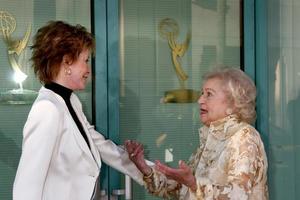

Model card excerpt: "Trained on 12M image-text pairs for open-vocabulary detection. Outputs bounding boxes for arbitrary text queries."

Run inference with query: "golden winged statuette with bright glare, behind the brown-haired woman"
[0,11,37,104]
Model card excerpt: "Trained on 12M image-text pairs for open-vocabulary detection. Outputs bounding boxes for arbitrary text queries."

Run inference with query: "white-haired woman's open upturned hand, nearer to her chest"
[155,160,197,191]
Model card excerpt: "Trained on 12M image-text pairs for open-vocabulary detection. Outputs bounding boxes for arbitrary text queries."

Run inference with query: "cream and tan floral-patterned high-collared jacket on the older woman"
[144,115,268,200]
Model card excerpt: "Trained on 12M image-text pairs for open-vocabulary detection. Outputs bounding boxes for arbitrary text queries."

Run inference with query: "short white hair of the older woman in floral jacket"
[204,67,256,123]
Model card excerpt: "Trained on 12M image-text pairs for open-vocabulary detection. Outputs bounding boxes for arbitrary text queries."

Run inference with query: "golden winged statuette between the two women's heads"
[159,18,199,103]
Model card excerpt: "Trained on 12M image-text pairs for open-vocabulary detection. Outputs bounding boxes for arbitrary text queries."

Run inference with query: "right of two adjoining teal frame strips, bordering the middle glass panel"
[107,0,123,193]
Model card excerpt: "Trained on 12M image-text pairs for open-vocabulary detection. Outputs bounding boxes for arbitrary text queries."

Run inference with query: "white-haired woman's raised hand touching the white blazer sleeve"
[124,140,152,175]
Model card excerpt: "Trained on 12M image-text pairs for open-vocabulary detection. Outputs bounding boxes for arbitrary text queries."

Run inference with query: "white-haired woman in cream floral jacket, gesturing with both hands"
[125,68,268,200]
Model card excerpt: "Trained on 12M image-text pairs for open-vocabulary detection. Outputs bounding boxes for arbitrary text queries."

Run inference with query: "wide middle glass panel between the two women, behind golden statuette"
[119,0,242,199]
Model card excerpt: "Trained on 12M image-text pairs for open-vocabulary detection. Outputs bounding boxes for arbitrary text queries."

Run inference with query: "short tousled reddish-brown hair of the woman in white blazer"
[31,21,95,83]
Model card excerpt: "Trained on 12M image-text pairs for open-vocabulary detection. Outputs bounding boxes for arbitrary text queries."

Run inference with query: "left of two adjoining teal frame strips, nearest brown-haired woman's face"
[92,0,109,193]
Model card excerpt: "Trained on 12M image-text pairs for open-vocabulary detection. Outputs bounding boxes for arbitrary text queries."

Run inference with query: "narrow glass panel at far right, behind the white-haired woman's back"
[268,0,300,200]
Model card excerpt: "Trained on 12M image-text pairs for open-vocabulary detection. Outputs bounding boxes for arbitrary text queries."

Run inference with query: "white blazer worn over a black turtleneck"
[13,87,143,200]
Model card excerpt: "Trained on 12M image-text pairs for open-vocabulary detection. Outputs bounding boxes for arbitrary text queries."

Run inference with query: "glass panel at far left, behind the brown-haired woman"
[0,0,92,199]
